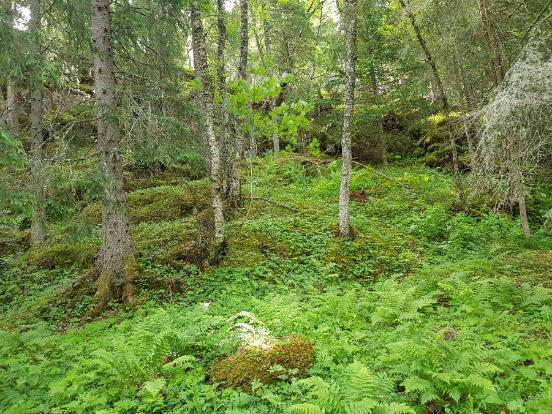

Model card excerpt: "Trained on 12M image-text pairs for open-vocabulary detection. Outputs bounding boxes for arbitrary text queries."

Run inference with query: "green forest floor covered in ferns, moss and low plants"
[0,155,552,414]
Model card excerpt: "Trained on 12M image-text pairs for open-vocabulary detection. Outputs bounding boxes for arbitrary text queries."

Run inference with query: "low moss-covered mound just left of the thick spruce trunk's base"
[27,240,100,269]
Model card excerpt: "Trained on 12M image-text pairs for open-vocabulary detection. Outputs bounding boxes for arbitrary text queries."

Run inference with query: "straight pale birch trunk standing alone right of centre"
[339,0,357,239]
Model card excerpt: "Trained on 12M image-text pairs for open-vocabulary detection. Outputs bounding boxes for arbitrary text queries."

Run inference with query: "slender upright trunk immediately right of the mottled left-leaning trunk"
[217,0,231,194]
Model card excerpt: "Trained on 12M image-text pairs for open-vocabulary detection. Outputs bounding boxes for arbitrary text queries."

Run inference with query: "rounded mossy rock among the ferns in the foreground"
[209,335,314,391]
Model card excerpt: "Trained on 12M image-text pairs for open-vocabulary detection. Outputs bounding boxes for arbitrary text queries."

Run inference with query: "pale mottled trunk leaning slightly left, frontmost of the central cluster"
[191,0,224,247]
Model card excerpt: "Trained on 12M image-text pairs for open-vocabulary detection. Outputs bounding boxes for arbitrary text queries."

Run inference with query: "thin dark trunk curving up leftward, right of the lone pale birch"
[399,0,465,205]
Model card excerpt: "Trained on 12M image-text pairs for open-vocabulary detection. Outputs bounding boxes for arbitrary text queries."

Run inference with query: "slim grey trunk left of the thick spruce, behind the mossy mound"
[29,0,46,246]
